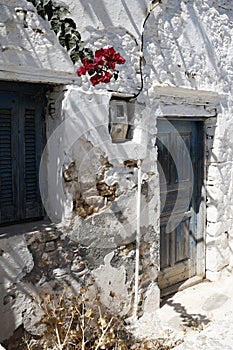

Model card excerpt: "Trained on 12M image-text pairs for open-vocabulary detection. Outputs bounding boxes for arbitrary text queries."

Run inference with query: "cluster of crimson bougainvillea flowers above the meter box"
[77,47,125,86]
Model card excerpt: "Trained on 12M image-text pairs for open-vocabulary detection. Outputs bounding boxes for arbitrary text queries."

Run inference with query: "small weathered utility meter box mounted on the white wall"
[109,100,129,142]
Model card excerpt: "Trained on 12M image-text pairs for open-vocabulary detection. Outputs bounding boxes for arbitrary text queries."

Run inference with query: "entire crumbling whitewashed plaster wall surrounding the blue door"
[0,0,233,339]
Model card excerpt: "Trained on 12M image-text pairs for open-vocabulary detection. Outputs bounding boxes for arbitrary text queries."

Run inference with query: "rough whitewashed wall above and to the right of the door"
[62,0,233,278]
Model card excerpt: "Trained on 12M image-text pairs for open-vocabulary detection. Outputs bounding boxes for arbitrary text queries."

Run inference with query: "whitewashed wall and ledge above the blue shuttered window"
[0,0,75,83]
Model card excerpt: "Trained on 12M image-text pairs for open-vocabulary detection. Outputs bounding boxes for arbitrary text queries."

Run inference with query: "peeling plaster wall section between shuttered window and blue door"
[41,87,159,309]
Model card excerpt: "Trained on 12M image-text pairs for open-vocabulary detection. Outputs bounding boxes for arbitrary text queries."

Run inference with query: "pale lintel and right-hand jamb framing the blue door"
[153,86,221,295]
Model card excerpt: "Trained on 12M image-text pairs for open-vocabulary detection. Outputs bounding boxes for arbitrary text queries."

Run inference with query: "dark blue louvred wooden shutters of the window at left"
[0,83,45,224]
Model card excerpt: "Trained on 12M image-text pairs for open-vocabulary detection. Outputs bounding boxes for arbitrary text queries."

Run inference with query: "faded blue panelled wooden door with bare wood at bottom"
[157,119,203,294]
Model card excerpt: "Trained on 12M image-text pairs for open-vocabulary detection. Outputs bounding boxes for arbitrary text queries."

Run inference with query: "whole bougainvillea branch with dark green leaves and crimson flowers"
[27,0,125,86]
